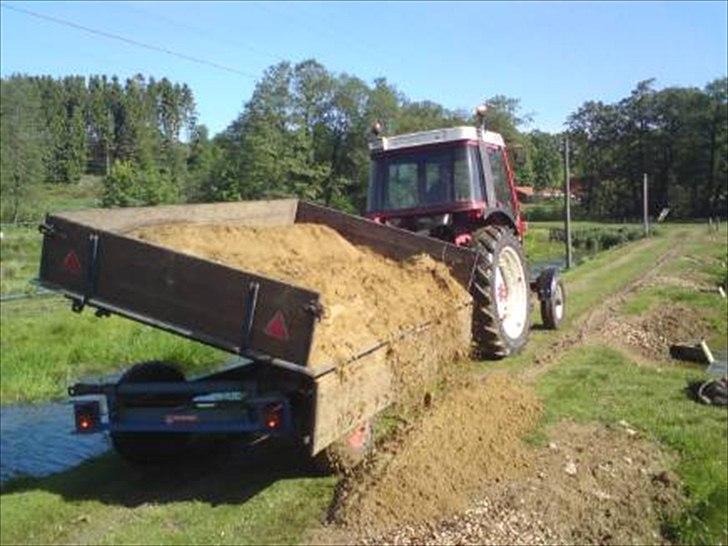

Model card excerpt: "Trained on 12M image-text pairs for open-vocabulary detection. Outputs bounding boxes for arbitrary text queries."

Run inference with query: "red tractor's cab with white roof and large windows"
[367,127,525,244]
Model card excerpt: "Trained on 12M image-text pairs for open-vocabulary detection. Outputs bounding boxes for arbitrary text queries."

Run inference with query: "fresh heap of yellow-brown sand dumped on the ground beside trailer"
[328,374,540,541]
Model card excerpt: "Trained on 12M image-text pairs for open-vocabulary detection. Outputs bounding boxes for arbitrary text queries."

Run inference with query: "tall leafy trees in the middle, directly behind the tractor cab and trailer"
[188,60,561,211]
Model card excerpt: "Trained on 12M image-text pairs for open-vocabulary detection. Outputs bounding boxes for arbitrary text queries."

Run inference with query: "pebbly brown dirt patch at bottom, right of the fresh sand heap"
[373,422,682,544]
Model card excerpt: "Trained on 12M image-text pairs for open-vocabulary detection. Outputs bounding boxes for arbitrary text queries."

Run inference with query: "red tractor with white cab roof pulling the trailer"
[367,108,565,358]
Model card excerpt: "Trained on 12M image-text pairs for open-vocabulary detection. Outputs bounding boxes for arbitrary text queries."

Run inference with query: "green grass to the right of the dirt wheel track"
[521,226,728,544]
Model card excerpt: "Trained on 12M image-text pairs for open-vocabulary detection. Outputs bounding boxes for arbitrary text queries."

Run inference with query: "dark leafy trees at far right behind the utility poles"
[568,78,728,218]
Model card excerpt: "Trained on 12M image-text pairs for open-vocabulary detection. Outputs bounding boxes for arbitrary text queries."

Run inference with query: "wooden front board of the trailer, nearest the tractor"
[296,201,476,288]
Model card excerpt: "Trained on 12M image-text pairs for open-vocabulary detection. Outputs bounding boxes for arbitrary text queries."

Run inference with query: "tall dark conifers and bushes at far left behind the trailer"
[0,75,196,221]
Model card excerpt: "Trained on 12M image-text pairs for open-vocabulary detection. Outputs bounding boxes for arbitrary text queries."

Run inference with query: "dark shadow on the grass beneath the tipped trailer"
[0,436,321,508]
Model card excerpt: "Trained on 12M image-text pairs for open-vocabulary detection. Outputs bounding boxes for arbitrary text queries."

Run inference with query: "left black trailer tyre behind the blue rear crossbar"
[110,362,190,465]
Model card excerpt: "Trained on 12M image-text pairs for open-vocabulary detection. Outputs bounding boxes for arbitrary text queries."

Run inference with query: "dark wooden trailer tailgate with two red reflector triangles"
[40,216,319,365]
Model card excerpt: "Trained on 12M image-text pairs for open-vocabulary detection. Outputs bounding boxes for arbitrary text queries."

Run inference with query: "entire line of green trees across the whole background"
[0,60,728,221]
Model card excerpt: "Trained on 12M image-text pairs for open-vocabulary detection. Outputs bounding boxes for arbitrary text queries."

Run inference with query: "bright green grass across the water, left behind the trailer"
[0,181,225,404]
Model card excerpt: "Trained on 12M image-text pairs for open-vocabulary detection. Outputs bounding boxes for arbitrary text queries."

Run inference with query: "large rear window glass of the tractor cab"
[367,143,483,212]
